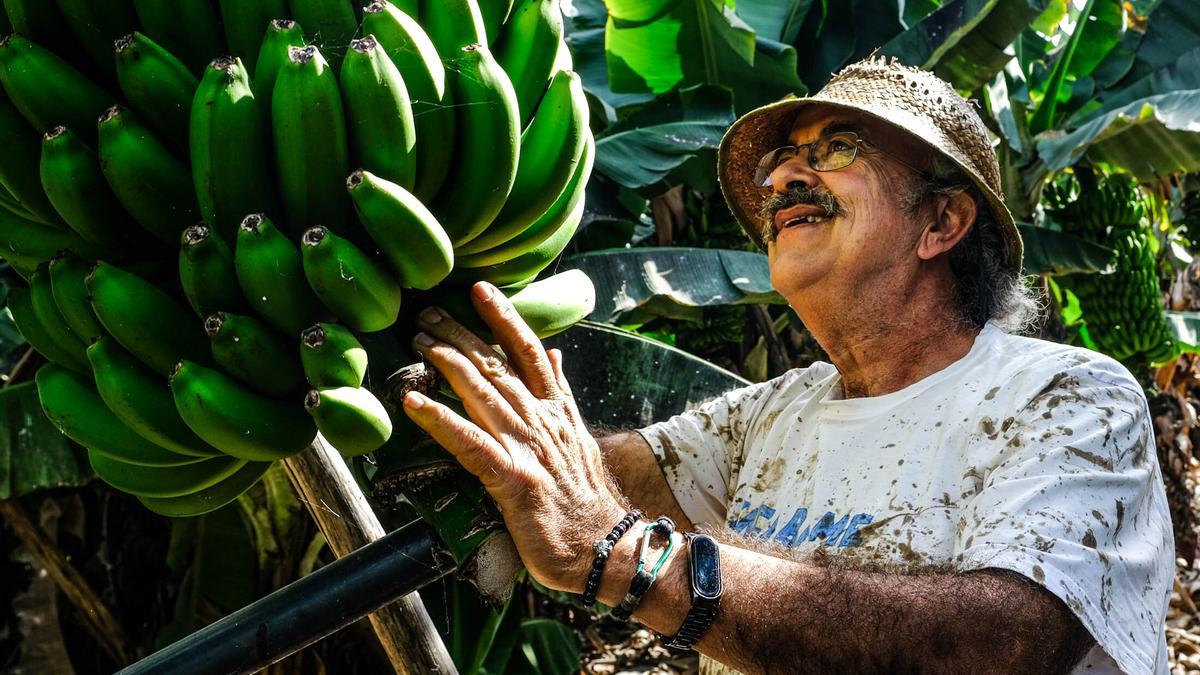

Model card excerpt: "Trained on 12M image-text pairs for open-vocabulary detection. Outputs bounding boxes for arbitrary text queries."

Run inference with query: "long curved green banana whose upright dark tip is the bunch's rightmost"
[431,44,521,246]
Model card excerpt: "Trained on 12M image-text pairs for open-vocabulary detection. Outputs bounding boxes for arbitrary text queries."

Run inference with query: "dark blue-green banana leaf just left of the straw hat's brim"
[595,85,734,189]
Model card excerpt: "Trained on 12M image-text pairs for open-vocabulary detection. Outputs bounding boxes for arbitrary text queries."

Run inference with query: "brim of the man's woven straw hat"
[716,96,1024,274]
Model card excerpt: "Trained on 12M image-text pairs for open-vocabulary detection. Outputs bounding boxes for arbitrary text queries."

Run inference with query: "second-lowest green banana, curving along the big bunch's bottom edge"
[88,450,246,497]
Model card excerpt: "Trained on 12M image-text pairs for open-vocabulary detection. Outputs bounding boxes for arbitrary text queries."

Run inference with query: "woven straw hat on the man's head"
[716,56,1022,274]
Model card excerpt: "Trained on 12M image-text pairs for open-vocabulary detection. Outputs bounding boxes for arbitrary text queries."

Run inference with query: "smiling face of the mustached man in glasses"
[764,108,929,297]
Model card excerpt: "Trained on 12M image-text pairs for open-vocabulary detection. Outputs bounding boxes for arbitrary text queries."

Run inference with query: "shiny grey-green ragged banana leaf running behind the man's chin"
[562,247,785,323]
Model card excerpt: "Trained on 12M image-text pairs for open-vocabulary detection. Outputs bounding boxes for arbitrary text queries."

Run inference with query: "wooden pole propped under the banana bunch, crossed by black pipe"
[283,436,457,675]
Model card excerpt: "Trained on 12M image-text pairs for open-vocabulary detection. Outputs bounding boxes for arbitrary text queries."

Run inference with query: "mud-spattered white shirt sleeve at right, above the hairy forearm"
[955,362,1175,674]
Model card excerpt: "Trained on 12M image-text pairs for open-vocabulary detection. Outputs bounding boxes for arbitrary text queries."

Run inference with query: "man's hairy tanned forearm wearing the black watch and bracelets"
[600,526,1091,674]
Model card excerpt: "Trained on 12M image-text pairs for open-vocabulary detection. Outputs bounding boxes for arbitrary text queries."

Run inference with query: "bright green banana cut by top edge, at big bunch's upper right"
[494,0,559,125]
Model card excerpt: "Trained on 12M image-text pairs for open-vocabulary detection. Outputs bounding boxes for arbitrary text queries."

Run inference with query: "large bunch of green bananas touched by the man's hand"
[0,0,594,515]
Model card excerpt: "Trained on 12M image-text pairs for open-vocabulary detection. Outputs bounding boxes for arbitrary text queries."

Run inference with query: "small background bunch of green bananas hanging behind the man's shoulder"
[1043,172,1180,363]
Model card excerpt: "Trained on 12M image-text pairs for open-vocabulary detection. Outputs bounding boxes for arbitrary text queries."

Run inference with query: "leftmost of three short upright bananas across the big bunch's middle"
[179,222,250,317]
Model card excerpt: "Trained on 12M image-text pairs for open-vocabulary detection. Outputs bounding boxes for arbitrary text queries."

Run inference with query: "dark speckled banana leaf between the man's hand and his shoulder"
[546,321,750,429]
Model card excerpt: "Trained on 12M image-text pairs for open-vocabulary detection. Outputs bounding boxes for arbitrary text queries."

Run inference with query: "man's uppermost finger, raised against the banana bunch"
[470,281,559,399]
